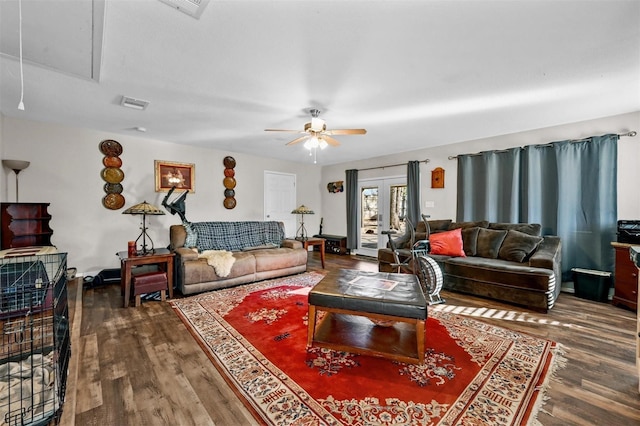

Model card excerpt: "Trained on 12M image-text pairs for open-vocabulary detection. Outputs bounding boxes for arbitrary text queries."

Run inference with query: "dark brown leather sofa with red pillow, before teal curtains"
[378,219,562,312]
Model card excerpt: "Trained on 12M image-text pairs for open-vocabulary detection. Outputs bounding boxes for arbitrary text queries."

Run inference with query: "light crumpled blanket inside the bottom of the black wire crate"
[0,352,58,425]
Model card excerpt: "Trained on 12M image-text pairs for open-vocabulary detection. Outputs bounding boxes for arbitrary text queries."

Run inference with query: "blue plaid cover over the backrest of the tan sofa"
[192,221,284,251]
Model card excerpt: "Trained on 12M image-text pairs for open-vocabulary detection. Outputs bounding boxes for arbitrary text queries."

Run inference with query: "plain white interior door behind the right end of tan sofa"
[264,171,296,238]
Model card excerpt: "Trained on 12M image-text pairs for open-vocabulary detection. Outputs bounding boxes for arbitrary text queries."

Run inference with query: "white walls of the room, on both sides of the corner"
[0,112,640,273]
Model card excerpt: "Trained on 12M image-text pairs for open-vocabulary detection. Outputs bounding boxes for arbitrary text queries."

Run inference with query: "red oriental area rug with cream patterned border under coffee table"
[171,273,560,426]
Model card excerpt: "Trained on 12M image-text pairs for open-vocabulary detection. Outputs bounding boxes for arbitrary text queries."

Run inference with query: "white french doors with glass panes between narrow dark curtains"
[356,177,407,257]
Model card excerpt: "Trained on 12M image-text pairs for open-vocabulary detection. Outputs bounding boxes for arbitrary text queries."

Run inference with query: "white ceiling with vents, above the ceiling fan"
[0,0,640,164]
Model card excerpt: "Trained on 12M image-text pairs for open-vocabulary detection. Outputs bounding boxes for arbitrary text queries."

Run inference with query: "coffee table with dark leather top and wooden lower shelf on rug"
[307,269,427,364]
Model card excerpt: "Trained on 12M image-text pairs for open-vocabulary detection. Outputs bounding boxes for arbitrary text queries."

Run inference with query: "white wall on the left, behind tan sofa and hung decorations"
[0,117,321,274]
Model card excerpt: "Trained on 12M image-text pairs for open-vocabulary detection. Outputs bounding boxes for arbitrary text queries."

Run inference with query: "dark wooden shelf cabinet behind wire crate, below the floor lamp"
[0,203,53,250]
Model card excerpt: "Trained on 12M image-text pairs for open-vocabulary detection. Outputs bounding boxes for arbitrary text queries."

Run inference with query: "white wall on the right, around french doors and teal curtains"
[322,112,640,235]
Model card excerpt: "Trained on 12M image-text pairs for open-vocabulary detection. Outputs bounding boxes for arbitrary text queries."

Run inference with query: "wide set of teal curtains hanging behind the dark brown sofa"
[456,134,619,280]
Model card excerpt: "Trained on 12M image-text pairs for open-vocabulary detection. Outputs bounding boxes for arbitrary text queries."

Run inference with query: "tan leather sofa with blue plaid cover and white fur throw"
[169,221,307,294]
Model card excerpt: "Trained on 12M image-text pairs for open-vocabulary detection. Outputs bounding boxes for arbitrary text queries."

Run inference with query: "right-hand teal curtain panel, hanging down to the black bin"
[522,135,619,280]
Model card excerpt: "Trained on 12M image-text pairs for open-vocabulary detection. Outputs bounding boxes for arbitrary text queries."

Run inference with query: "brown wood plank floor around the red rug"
[62,253,640,426]
